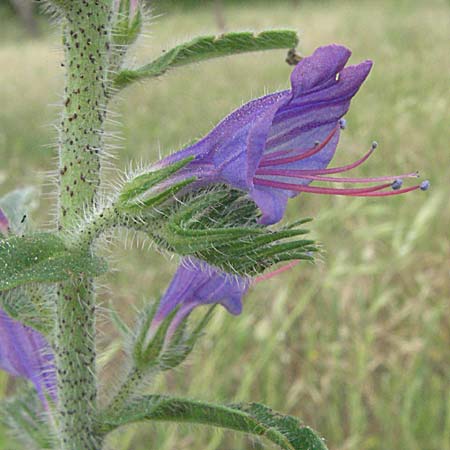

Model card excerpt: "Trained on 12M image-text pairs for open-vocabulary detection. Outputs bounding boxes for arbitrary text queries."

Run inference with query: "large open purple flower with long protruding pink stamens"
[157,45,428,224]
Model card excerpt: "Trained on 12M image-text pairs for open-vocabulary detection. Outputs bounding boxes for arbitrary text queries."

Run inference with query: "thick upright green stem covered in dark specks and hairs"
[55,0,111,450]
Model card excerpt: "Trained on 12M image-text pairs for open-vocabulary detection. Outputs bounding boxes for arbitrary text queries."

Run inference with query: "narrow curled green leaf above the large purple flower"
[115,30,298,88]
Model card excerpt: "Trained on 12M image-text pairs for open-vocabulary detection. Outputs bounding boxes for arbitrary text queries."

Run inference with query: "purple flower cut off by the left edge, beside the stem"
[0,309,56,407]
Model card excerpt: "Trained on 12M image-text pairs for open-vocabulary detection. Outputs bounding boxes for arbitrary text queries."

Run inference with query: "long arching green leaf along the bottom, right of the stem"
[99,395,326,450]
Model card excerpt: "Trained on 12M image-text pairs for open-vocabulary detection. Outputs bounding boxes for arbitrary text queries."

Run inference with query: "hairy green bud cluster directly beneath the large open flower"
[143,186,317,276]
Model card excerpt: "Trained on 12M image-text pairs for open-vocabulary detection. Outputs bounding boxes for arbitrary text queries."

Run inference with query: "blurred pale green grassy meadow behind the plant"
[0,0,450,450]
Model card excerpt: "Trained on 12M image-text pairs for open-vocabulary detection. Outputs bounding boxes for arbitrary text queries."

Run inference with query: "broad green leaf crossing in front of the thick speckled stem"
[0,233,107,291]
